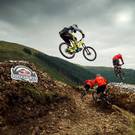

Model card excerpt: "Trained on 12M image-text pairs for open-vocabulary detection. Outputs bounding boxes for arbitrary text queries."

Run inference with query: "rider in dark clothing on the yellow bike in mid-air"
[59,24,85,52]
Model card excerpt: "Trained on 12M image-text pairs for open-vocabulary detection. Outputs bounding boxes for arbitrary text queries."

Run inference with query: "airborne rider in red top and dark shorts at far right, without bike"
[113,54,124,66]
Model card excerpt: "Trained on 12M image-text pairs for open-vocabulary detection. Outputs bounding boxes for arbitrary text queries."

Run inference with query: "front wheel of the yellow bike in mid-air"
[83,46,97,61]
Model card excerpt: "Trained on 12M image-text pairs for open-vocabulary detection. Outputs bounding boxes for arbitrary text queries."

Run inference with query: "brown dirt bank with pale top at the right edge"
[110,83,135,113]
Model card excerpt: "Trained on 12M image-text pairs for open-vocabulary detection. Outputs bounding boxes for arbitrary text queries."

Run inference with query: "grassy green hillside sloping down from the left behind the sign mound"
[0,41,94,84]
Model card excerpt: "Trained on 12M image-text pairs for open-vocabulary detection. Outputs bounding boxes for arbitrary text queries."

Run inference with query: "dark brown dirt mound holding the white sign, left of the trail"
[0,62,77,135]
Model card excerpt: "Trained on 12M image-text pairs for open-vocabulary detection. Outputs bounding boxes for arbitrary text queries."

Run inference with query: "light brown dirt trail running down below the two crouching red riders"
[55,87,129,135]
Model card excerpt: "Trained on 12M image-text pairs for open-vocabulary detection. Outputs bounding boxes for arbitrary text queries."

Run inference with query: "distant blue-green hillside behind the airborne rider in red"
[85,66,135,84]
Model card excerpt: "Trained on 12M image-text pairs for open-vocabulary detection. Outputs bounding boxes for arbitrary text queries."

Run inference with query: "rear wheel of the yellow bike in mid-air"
[59,43,75,59]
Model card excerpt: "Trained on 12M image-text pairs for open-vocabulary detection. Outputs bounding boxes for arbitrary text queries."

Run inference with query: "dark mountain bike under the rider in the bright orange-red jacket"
[92,88,112,108]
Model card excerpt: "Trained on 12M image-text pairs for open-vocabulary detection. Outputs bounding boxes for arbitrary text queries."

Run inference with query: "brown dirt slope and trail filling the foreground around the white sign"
[0,62,132,135]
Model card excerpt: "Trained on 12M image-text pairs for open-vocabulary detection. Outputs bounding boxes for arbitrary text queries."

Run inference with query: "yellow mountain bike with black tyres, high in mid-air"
[59,38,97,61]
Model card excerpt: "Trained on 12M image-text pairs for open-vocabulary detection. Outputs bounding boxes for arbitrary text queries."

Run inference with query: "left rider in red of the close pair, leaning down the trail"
[81,80,94,98]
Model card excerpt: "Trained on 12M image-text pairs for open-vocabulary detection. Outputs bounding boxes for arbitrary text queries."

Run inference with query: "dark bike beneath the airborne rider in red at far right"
[114,65,124,81]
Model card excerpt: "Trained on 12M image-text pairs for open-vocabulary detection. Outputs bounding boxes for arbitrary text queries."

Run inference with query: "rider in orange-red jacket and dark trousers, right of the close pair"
[94,74,107,94]
